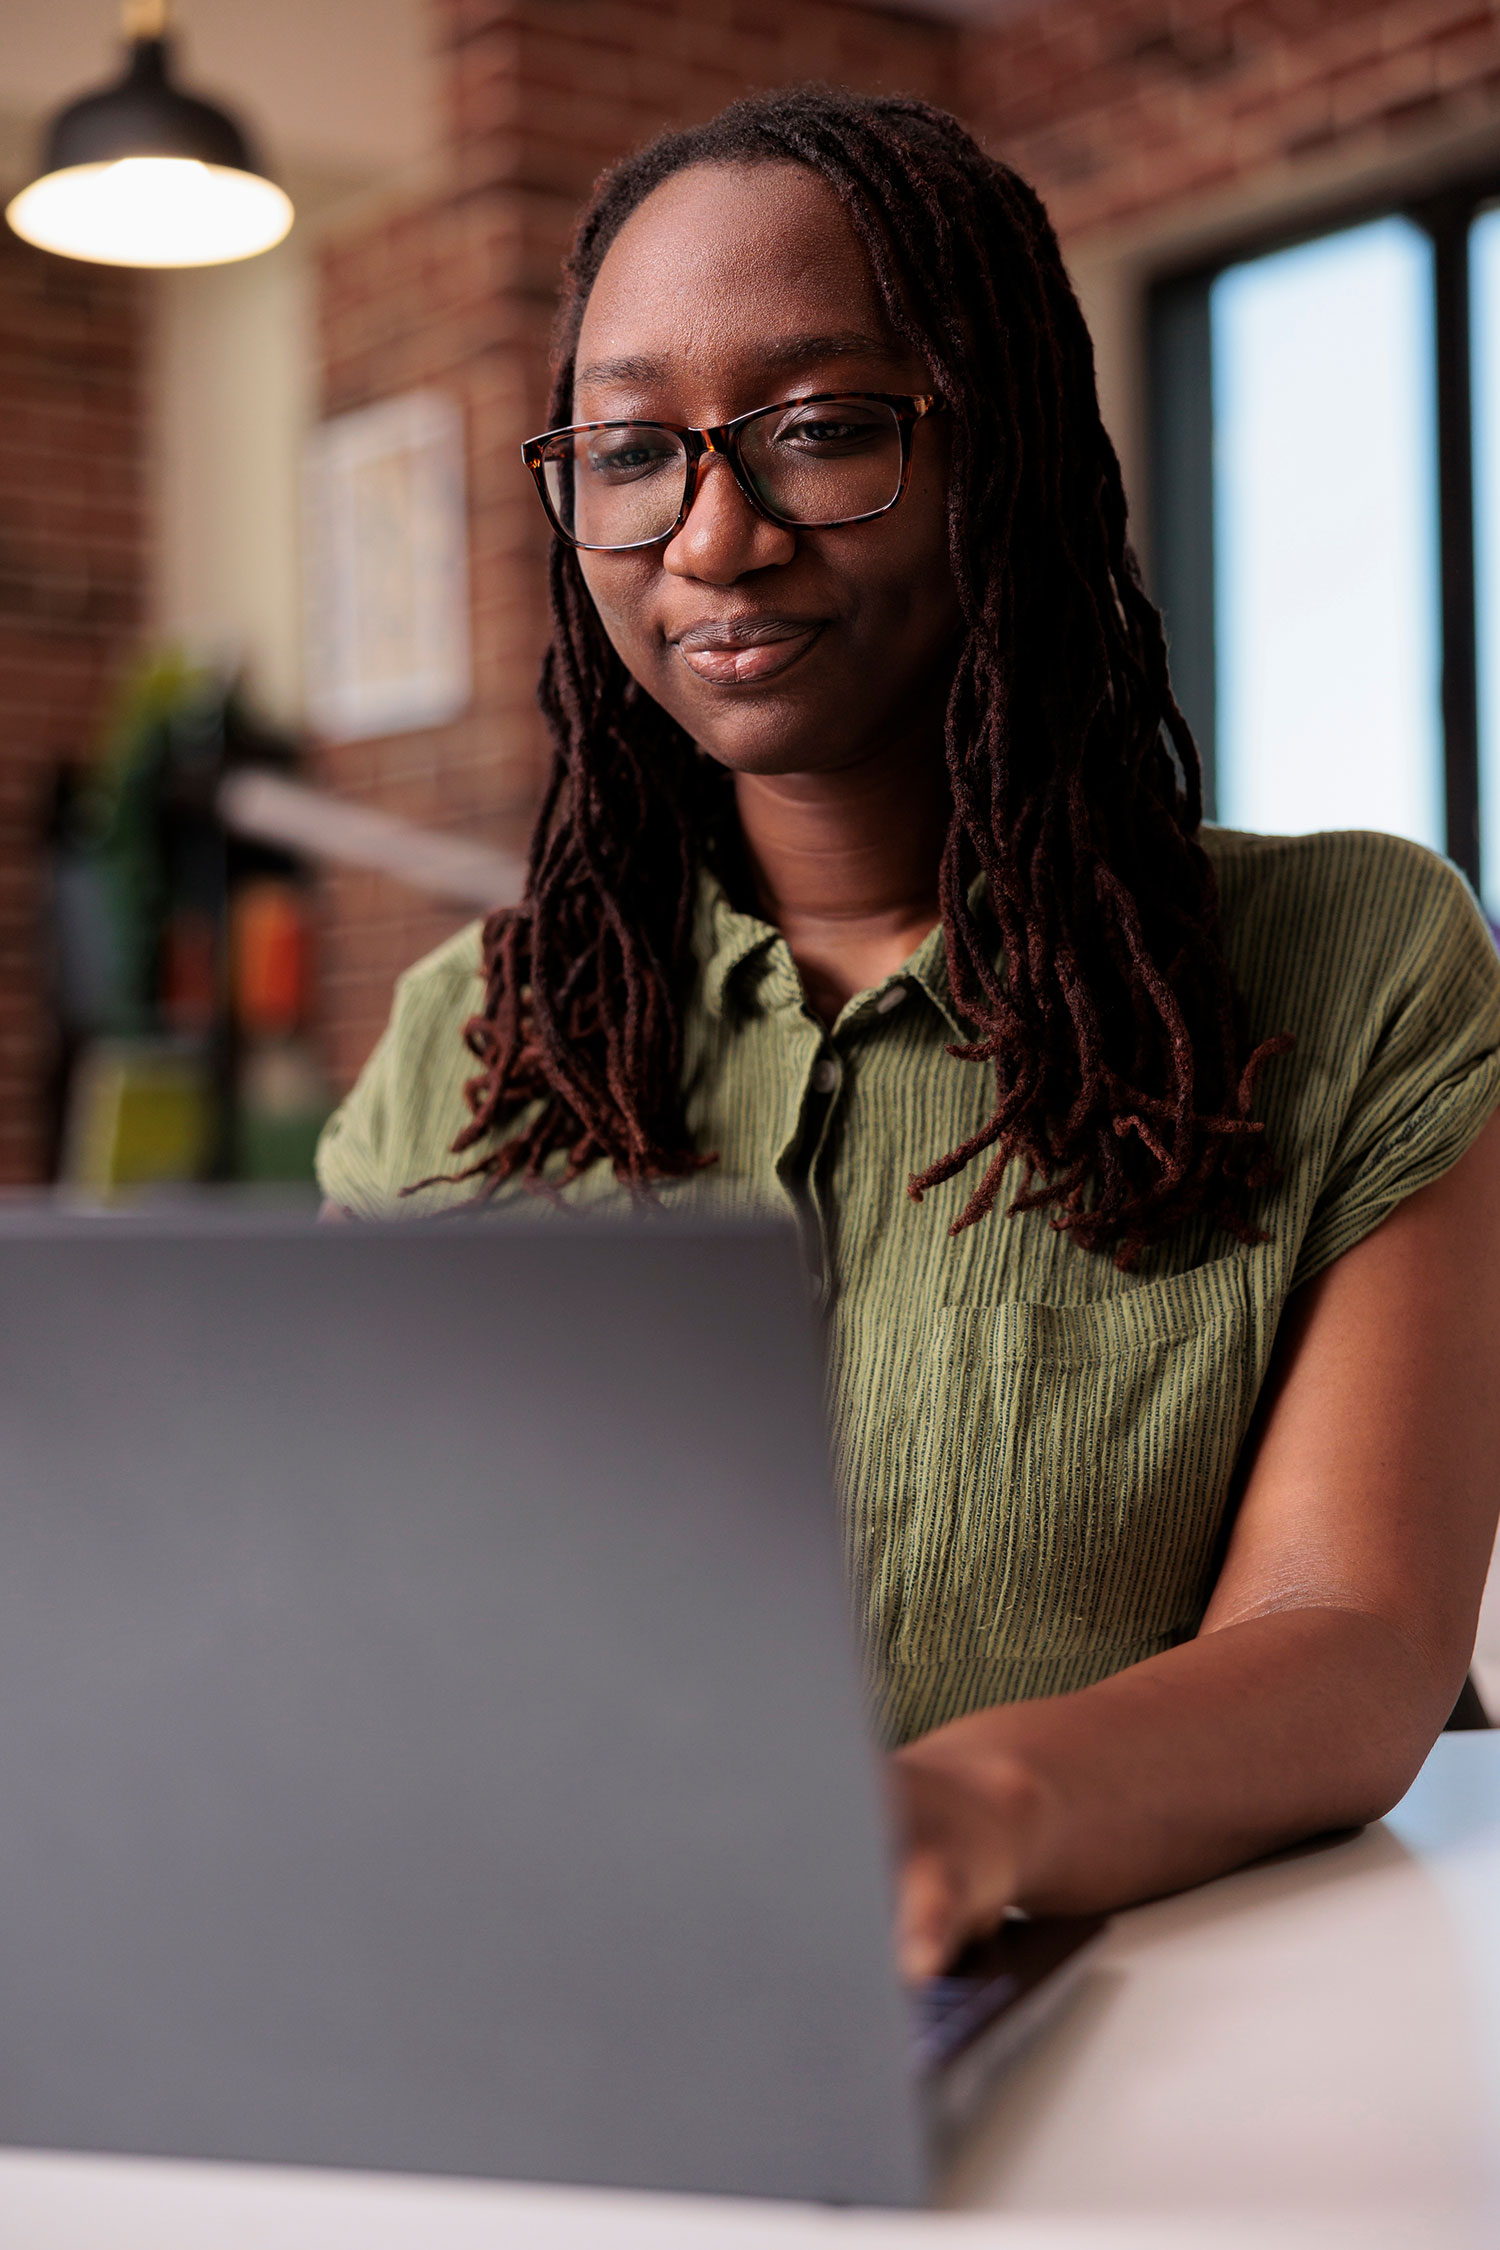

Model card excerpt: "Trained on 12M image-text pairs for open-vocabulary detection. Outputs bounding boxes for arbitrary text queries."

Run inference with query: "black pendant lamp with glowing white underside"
[4,0,292,266]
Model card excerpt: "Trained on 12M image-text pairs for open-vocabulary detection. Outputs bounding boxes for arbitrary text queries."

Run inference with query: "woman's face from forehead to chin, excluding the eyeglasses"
[573,164,960,774]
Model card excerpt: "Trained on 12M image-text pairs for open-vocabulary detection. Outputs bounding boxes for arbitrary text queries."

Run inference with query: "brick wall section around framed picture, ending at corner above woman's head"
[319,0,958,1085]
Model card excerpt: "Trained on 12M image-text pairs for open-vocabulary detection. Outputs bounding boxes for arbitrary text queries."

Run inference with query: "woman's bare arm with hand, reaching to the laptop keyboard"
[893,1116,1500,1976]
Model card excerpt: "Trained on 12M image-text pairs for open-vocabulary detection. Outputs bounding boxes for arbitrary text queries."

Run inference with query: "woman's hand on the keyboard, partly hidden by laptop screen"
[891,1730,1043,1985]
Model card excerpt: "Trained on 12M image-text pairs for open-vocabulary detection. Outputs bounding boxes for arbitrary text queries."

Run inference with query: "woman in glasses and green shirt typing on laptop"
[322,90,1500,1976]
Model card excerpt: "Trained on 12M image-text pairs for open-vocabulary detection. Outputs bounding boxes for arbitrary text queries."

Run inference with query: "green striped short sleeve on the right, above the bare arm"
[1293,837,1500,1287]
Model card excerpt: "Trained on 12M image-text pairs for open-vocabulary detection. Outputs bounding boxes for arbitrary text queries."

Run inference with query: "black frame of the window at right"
[1145,167,1500,889]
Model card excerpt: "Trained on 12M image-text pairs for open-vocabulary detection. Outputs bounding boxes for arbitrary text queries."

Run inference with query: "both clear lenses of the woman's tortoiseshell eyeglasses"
[542,398,902,547]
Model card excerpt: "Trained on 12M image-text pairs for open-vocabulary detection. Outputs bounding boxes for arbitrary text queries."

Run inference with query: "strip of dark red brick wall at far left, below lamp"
[0,225,146,1186]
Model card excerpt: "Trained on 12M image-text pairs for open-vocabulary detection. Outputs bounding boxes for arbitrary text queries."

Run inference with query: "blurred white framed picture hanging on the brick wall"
[304,392,472,743]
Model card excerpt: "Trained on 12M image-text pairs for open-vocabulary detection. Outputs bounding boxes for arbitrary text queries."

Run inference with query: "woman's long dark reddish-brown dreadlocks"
[454,86,1289,1265]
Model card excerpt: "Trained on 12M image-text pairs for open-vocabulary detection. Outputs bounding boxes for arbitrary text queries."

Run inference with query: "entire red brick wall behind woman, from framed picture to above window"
[322,0,1500,1082]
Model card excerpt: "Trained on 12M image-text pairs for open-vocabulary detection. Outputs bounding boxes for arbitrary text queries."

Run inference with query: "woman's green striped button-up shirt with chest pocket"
[319,830,1500,1742]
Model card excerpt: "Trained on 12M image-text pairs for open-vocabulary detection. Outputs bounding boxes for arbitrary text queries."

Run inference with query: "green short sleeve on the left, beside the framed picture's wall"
[315,923,484,1217]
